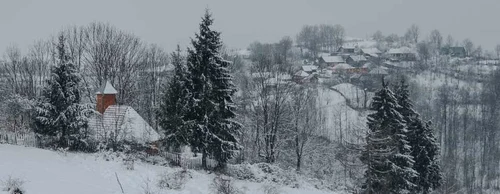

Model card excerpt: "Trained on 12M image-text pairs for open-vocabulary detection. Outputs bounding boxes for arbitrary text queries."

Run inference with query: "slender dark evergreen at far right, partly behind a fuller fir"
[396,78,442,193]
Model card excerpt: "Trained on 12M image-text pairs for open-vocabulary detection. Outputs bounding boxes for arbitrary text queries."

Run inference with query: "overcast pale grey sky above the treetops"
[0,0,500,54]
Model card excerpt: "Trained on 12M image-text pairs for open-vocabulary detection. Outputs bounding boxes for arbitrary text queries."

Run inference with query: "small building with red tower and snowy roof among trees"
[89,81,160,143]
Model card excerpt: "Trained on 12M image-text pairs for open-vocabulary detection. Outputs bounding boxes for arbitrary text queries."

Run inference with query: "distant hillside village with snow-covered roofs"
[237,39,474,91]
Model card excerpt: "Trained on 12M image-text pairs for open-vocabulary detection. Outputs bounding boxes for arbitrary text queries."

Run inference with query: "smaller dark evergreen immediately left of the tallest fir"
[157,45,192,149]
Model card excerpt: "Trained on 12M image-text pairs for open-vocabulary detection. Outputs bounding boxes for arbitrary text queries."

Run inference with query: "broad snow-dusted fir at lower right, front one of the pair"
[361,79,418,194]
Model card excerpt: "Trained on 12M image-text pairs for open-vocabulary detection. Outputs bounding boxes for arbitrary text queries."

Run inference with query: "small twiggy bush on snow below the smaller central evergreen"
[158,168,192,190]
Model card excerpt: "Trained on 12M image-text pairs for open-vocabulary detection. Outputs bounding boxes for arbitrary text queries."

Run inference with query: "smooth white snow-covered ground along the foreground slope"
[0,144,340,194]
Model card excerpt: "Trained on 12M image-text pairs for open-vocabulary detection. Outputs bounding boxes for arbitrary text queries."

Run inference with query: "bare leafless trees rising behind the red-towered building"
[0,22,170,135]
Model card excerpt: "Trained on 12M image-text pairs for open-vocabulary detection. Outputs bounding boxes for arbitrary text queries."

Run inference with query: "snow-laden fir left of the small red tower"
[35,35,89,150]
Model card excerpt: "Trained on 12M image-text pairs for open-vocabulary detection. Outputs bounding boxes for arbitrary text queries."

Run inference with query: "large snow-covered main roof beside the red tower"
[89,105,160,143]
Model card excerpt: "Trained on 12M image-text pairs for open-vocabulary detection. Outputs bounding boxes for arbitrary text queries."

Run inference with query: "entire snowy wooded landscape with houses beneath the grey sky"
[0,4,500,194]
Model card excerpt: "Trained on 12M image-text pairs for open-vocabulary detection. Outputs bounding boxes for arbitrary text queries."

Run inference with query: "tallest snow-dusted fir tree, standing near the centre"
[186,10,241,168]
